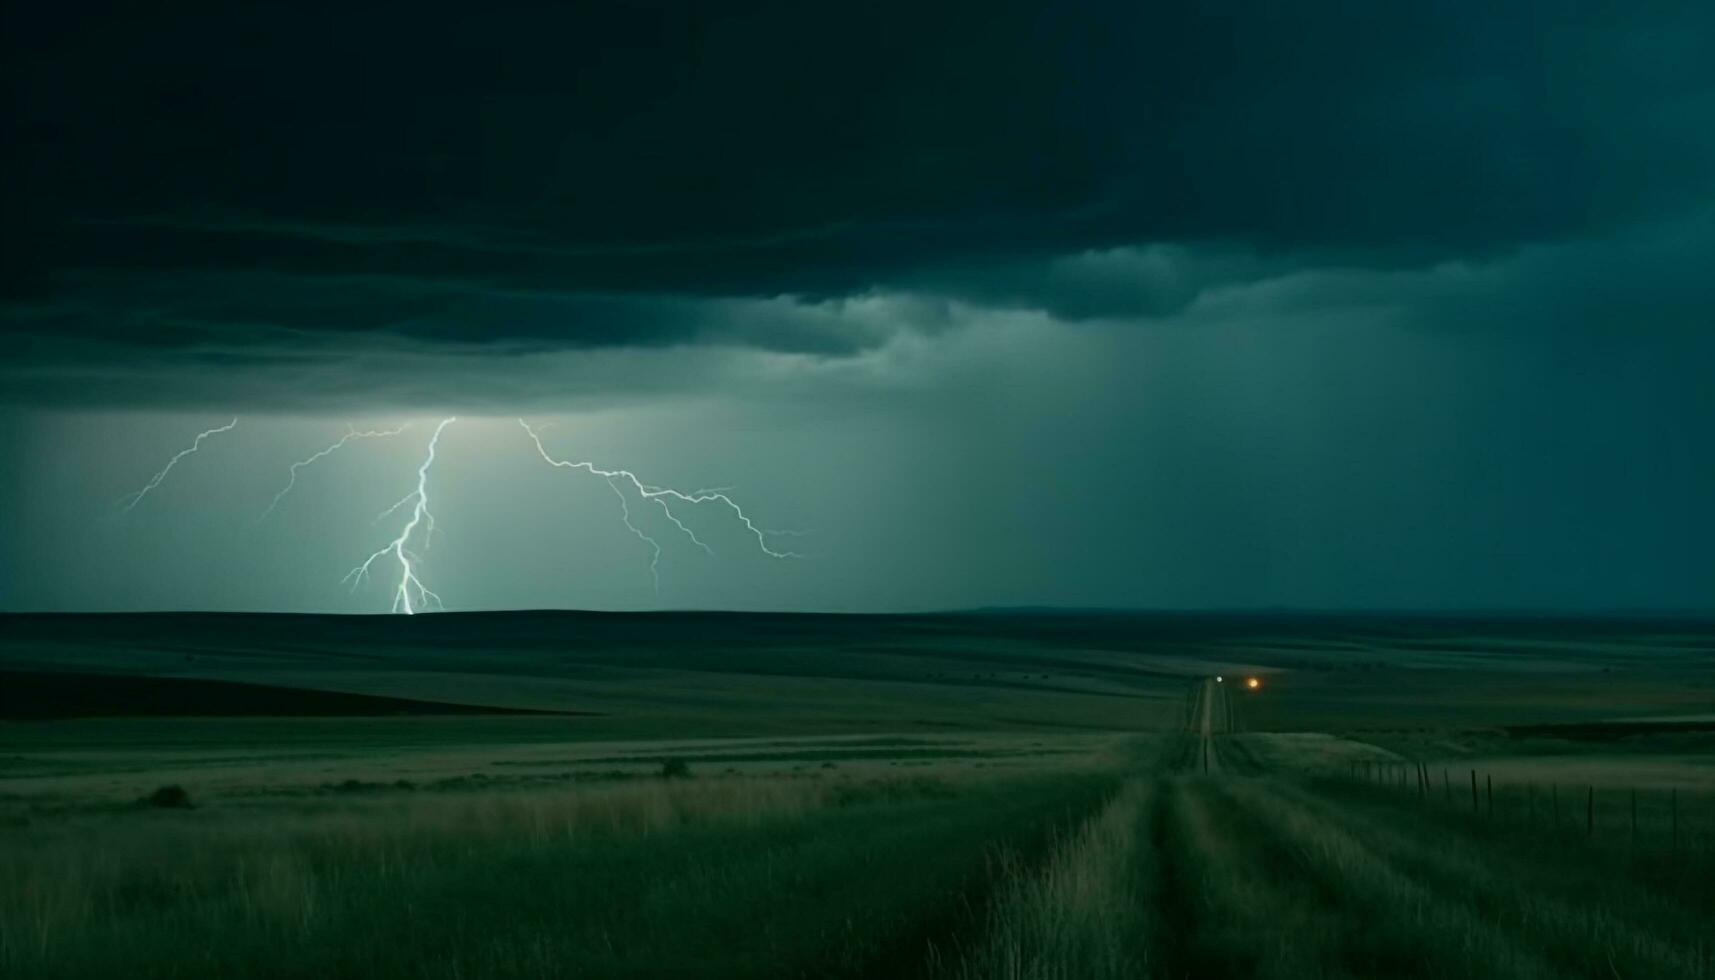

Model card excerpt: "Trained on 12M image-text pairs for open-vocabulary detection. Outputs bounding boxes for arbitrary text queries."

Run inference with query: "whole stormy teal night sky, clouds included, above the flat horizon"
[0,0,1715,613]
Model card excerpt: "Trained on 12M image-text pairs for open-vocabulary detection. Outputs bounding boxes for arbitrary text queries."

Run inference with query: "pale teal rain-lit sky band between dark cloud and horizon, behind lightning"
[0,307,1715,613]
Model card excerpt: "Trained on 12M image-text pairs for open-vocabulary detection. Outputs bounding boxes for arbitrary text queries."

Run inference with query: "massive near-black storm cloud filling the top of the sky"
[0,0,1715,398]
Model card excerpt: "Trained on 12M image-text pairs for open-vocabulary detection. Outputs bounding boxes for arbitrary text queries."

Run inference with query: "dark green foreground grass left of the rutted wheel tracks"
[0,776,1113,978]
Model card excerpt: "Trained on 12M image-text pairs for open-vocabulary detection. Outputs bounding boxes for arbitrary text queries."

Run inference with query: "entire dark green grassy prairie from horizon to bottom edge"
[0,614,1715,978]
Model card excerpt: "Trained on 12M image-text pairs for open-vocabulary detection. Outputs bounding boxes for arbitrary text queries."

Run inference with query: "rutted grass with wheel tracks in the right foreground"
[957,776,1715,980]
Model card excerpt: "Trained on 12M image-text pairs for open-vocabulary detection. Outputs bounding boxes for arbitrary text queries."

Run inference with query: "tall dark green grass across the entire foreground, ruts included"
[10,743,1715,980]
